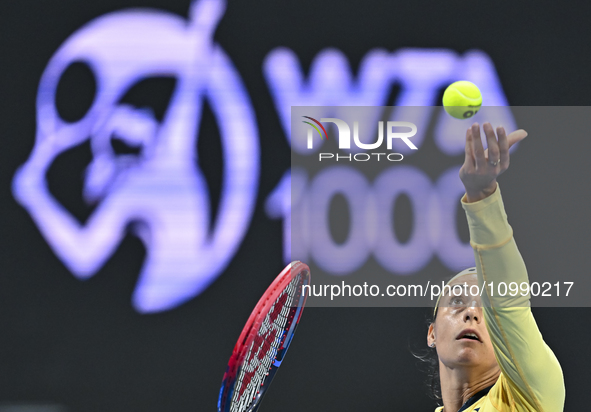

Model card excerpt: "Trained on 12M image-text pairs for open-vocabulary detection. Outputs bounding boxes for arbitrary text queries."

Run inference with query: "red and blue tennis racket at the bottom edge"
[218,261,310,412]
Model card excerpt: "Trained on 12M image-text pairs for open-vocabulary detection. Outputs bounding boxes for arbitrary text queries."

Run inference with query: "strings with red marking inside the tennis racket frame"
[230,275,302,412]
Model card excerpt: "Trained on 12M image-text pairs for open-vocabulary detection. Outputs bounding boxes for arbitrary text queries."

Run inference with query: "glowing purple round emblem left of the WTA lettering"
[13,0,259,312]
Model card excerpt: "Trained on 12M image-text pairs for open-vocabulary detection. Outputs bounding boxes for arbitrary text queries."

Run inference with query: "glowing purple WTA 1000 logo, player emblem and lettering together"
[13,0,515,312]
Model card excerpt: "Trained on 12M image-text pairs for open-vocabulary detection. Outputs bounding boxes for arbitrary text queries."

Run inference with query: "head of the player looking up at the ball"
[427,268,499,388]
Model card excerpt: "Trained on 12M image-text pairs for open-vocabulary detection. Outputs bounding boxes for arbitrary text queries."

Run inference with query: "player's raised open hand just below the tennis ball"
[460,122,527,203]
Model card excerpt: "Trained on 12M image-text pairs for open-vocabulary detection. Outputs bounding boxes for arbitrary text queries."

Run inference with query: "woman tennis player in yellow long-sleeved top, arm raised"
[427,123,565,412]
